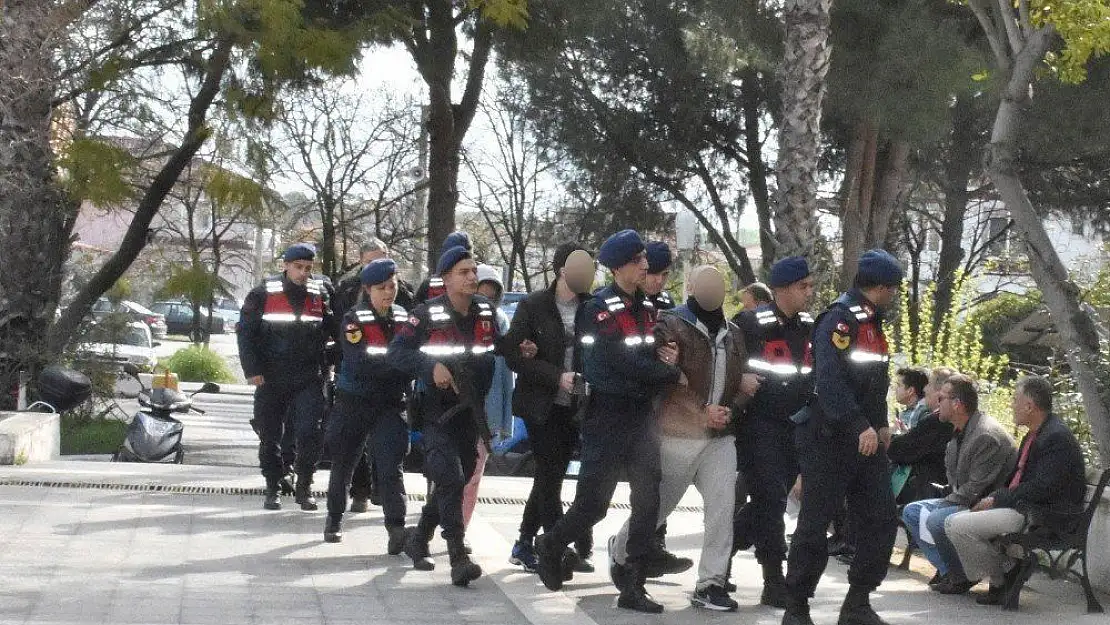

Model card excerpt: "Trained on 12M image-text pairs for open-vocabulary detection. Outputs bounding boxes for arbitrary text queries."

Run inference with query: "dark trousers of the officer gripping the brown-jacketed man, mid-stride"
[549,394,663,564]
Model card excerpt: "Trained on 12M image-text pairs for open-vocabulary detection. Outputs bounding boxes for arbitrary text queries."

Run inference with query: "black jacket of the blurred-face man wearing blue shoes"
[500,283,589,423]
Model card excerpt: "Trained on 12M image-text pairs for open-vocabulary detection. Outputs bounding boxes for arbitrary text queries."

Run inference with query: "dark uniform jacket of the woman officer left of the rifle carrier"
[335,304,412,412]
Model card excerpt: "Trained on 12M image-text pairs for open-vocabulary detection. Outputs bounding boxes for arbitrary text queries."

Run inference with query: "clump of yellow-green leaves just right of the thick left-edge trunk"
[58,139,138,206]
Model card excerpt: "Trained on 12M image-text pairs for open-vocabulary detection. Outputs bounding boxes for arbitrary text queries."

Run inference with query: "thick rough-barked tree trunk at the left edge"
[0,0,79,395]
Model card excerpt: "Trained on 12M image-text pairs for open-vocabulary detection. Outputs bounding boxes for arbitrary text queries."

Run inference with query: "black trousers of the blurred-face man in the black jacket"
[521,405,578,538]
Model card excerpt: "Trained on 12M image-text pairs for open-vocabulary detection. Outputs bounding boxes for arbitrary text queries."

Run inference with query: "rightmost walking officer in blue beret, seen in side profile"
[783,250,902,625]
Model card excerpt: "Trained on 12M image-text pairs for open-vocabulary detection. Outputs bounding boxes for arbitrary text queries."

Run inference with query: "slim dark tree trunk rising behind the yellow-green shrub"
[930,94,980,335]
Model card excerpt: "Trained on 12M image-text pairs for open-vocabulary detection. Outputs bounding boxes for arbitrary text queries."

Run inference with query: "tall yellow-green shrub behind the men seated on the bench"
[895,275,1009,384]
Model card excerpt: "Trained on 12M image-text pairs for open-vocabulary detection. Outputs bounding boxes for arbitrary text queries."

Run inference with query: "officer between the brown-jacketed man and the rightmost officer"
[734,256,814,607]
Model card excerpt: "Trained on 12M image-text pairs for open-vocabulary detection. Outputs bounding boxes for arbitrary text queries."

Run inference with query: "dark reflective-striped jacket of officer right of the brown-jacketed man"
[735,304,814,421]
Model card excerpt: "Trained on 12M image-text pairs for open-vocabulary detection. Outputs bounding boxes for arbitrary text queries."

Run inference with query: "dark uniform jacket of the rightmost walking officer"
[810,289,890,435]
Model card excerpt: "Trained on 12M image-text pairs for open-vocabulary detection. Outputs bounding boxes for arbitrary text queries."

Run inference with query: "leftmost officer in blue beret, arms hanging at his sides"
[236,243,334,511]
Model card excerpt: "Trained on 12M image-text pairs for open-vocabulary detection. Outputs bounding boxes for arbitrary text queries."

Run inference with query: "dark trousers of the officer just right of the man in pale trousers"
[733,413,798,564]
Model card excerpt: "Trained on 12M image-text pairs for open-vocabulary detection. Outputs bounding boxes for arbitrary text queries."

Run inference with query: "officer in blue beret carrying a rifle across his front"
[387,245,500,586]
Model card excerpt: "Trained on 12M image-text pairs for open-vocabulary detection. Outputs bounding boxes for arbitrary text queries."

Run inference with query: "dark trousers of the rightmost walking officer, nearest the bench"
[786,421,898,599]
